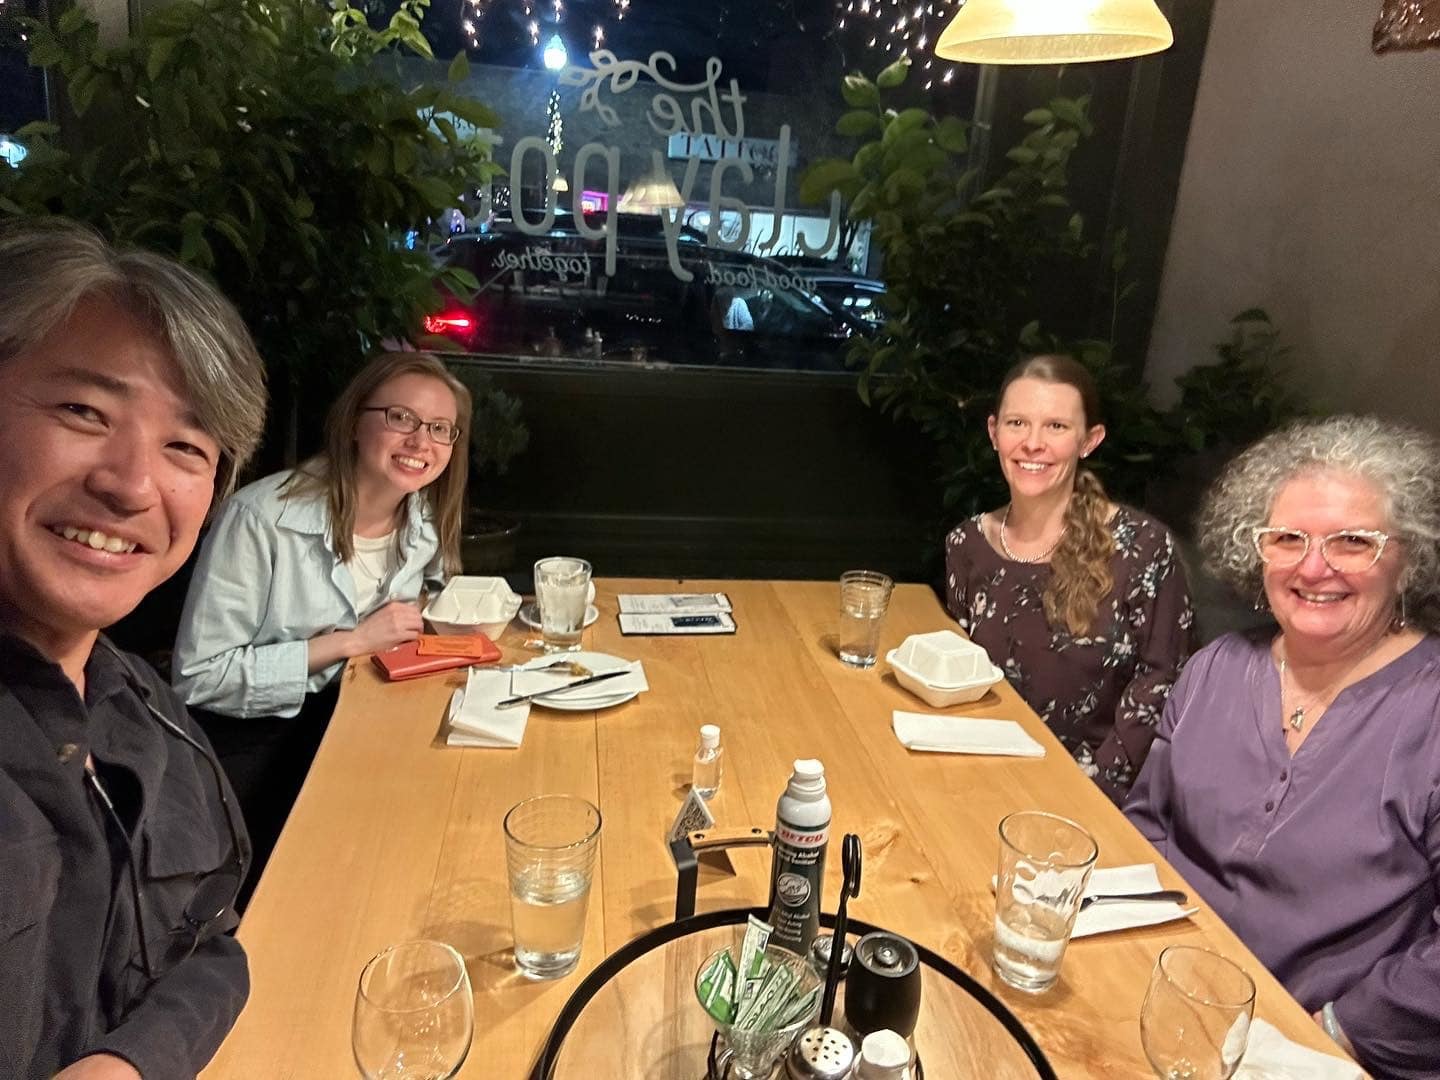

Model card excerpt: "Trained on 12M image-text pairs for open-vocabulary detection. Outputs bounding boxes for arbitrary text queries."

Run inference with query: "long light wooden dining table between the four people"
[206,580,1338,1080]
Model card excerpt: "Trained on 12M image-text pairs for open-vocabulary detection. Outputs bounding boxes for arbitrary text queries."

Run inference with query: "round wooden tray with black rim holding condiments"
[530,909,1057,1080]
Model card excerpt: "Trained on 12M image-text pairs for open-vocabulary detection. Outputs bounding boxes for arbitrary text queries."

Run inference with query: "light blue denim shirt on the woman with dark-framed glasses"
[171,472,442,717]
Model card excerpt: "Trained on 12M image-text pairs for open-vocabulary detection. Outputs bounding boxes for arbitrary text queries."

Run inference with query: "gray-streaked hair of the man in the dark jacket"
[0,217,265,498]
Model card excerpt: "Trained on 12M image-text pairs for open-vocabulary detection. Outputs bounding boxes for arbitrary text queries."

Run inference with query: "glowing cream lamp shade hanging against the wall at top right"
[935,0,1175,63]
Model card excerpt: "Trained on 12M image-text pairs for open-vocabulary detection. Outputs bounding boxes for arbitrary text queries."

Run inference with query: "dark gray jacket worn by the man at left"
[0,635,249,1080]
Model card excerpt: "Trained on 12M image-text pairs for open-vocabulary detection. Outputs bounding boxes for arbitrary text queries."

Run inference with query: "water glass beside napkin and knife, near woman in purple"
[994,811,1100,994]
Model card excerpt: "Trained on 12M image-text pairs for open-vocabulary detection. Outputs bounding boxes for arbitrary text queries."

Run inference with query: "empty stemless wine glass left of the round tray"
[350,942,475,1080]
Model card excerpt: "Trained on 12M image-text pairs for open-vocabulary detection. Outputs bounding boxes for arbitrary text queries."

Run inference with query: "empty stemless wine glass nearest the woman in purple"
[1140,945,1256,1080]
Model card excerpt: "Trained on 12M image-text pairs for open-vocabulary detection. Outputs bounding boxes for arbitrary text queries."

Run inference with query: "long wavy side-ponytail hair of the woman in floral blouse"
[995,356,1115,638]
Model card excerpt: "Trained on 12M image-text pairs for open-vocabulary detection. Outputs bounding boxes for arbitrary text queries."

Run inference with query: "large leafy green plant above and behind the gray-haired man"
[0,0,498,459]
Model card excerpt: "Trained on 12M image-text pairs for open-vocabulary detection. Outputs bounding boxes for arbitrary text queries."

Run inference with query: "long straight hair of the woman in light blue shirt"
[282,353,472,573]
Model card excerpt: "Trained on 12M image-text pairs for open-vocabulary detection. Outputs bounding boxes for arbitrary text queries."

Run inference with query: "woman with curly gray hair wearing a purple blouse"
[1126,416,1440,1077]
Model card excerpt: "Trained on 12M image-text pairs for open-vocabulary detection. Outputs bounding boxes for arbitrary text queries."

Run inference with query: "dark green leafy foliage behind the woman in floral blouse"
[801,60,1300,517]
